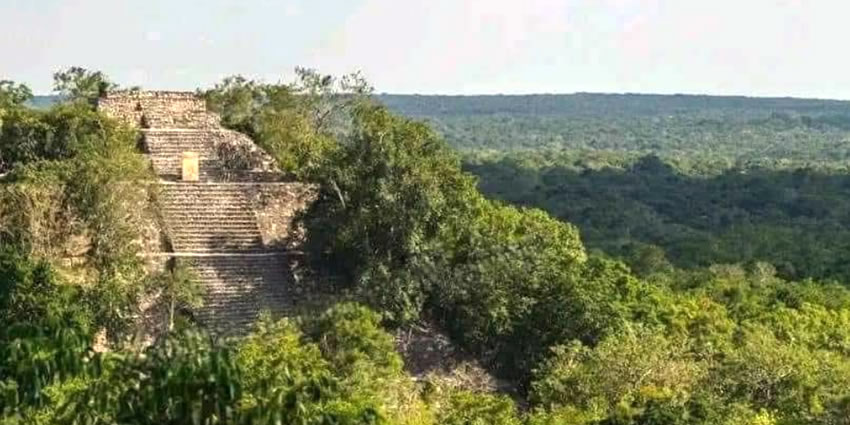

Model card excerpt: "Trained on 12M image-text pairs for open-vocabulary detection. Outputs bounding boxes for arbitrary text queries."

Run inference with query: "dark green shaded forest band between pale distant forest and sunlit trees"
[466,153,850,280]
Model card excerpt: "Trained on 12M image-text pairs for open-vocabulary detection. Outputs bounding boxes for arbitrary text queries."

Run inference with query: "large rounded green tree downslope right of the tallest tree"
[430,201,588,378]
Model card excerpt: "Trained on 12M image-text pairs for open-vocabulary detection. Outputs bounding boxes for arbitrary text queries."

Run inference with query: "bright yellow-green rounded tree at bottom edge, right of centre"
[532,326,706,420]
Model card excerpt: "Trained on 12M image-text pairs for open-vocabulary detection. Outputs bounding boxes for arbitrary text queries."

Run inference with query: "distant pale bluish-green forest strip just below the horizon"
[379,94,850,161]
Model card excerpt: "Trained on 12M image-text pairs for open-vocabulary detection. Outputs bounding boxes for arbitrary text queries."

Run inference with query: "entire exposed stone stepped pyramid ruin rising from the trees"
[98,91,315,333]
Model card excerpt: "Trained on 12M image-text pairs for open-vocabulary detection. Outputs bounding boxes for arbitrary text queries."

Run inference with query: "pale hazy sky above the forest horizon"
[0,0,850,99]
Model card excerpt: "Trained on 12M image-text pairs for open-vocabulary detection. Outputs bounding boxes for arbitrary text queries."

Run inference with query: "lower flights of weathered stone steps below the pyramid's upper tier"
[159,181,297,334]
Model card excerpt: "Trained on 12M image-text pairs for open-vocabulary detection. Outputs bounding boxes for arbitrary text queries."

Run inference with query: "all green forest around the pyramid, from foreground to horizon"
[0,68,850,425]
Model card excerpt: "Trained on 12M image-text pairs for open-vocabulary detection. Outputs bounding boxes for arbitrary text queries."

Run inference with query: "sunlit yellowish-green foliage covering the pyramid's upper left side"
[0,78,152,336]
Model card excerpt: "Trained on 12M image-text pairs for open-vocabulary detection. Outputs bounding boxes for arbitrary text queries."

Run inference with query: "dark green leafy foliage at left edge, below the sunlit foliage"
[0,249,93,417]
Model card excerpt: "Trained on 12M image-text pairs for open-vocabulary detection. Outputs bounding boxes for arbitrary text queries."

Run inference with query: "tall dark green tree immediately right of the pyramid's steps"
[307,105,477,321]
